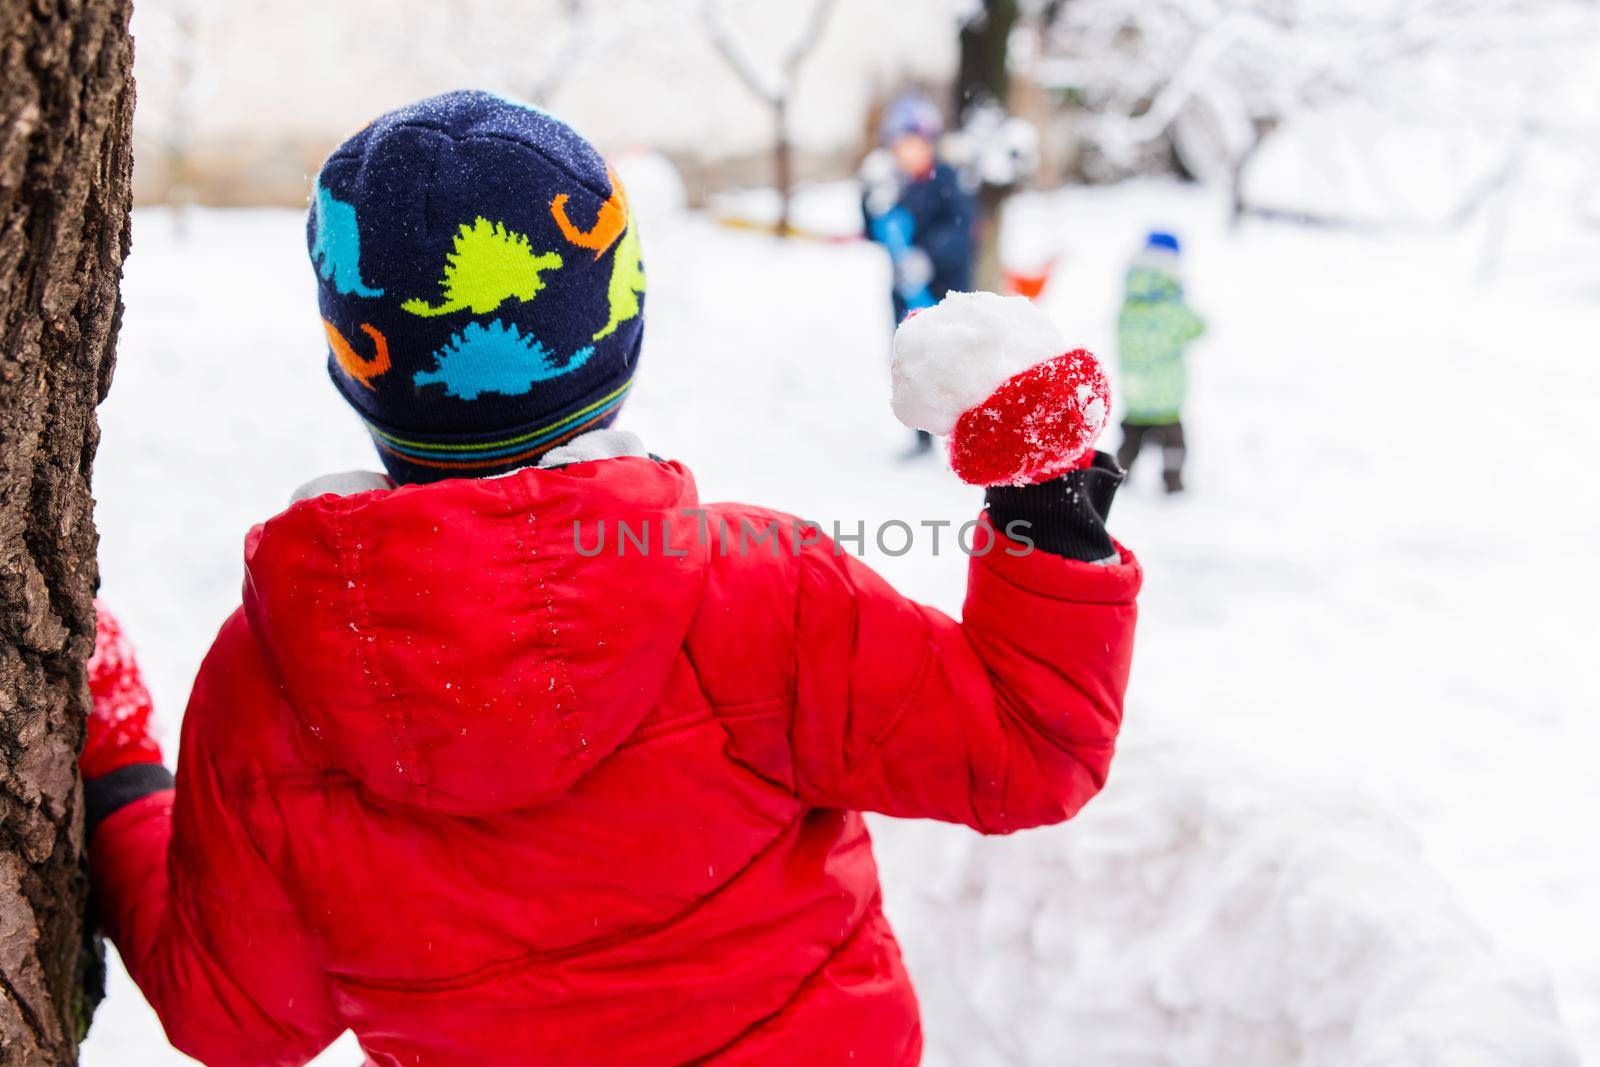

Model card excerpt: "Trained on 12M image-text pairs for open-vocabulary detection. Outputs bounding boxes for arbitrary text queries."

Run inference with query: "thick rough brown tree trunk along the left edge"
[0,0,133,1067]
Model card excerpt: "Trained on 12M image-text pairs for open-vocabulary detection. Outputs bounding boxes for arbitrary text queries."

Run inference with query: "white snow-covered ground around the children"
[83,182,1600,1067]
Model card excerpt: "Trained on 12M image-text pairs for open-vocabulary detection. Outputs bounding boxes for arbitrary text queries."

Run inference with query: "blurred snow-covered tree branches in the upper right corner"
[1029,0,1600,230]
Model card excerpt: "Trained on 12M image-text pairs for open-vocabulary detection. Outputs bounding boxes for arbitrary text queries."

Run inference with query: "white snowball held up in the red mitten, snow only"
[890,293,1067,434]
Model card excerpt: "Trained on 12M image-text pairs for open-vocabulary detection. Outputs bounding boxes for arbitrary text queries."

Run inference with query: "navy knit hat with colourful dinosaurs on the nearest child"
[306,91,645,482]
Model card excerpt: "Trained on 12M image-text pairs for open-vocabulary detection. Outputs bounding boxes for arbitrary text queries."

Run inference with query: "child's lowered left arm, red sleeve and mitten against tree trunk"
[80,609,344,1067]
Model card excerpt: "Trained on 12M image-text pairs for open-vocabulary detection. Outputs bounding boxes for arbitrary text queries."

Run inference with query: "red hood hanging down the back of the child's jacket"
[245,458,709,814]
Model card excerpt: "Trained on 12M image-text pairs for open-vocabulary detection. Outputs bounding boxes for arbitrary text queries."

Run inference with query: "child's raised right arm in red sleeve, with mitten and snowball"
[691,293,1141,833]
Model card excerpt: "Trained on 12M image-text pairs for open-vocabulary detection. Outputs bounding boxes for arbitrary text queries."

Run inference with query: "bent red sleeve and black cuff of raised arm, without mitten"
[691,467,1141,833]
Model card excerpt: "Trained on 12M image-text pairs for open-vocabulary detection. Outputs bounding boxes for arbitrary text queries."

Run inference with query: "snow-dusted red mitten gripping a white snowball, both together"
[893,293,1110,486]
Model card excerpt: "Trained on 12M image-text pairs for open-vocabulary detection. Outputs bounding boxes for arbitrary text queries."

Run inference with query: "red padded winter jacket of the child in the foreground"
[93,458,1139,1067]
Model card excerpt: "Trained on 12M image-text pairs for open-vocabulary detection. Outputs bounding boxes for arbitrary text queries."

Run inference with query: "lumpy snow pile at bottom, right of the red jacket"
[877,735,1578,1067]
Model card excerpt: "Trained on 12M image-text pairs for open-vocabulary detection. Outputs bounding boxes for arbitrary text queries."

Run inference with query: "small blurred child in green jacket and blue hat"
[1117,232,1205,493]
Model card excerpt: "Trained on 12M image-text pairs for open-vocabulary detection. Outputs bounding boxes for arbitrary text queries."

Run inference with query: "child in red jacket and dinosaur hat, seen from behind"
[82,93,1139,1067]
